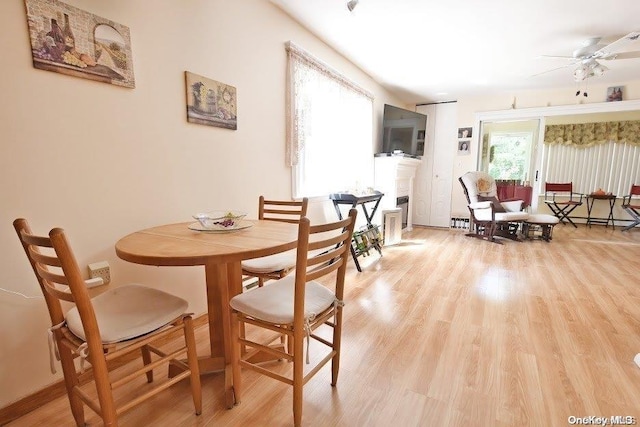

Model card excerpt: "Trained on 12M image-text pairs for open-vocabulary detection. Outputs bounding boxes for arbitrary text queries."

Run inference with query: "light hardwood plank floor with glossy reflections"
[9,225,640,427]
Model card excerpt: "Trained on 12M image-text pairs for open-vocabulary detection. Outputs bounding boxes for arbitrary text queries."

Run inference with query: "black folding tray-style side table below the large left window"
[329,191,384,271]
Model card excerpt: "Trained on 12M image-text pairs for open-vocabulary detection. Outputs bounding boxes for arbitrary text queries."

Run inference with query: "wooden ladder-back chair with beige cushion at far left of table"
[13,219,202,426]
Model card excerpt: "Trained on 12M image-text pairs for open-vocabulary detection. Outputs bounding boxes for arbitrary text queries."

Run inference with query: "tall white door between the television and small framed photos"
[413,102,458,228]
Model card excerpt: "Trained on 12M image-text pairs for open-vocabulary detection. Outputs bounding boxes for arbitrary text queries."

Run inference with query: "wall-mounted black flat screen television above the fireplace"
[382,104,427,157]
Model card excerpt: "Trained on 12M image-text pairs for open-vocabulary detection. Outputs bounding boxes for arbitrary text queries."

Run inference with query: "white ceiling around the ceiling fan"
[271,0,640,103]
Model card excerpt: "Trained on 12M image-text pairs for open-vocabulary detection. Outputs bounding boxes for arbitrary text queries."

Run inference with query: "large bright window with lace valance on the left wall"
[287,42,373,198]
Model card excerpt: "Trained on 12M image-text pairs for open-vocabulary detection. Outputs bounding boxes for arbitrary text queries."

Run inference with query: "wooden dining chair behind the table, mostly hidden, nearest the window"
[242,196,309,287]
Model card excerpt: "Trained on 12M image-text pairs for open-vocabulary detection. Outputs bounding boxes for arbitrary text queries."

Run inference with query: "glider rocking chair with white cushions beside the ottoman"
[459,171,529,243]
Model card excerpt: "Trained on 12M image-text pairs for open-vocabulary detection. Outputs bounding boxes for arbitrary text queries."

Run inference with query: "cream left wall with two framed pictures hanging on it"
[0,0,402,407]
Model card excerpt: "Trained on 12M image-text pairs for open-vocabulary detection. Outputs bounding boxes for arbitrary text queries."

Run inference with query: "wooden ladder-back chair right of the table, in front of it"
[230,209,357,426]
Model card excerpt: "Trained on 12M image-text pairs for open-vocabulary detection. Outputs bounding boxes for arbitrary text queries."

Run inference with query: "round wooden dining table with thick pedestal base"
[116,220,298,407]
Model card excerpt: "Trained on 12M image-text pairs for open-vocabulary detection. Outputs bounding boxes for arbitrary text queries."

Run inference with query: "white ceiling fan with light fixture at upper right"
[535,31,640,82]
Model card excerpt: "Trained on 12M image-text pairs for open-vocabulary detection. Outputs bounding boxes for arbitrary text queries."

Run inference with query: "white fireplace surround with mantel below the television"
[374,155,422,231]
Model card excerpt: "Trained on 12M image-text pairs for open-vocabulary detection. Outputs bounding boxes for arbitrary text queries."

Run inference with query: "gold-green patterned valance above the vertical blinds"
[544,120,640,148]
